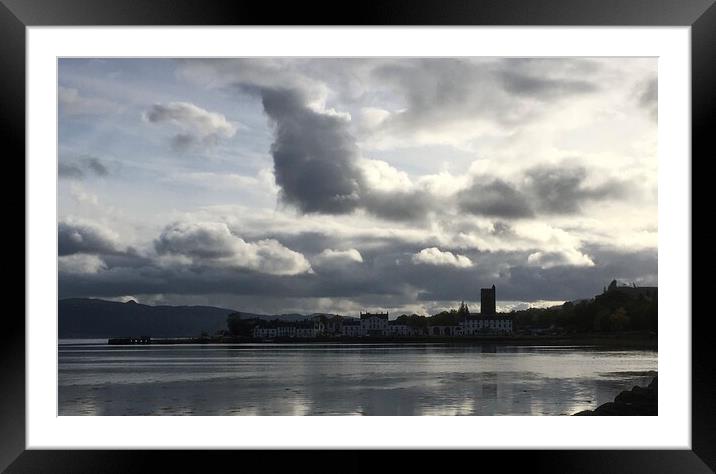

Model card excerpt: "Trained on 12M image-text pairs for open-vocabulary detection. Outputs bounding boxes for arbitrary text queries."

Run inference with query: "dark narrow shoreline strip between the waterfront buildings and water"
[107,333,658,350]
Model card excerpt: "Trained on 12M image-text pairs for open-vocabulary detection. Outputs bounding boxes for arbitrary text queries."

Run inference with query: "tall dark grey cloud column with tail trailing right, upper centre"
[258,87,432,220]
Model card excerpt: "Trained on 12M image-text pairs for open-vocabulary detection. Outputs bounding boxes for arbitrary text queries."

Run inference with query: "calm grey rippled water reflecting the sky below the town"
[58,340,657,415]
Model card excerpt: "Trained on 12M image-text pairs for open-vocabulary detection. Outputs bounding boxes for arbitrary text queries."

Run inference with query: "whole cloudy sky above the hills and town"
[58,57,658,316]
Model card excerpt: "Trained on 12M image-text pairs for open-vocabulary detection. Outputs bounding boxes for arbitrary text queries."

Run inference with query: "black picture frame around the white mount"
[0,0,716,473]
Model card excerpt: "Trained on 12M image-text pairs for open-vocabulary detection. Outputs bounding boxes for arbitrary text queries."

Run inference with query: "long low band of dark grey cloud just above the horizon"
[60,229,657,310]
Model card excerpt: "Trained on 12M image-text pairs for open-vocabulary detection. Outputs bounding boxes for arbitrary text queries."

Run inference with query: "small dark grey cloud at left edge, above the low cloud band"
[57,222,122,256]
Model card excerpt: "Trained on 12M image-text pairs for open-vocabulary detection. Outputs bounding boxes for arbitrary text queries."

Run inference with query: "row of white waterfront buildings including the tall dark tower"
[253,285,512,339]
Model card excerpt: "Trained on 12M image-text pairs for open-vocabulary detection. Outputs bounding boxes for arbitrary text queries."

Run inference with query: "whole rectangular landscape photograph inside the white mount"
[58,56,656,417]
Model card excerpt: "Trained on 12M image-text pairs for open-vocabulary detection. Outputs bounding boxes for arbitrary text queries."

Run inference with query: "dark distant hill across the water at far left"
[58,298,338,339]
